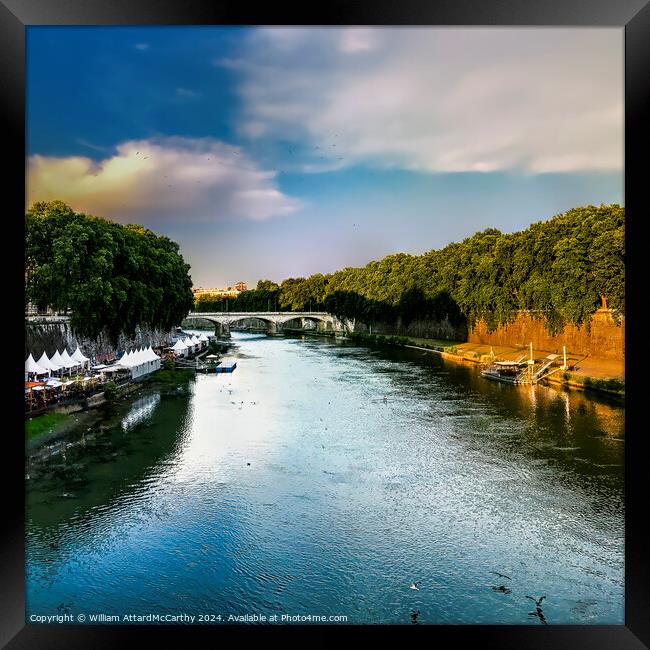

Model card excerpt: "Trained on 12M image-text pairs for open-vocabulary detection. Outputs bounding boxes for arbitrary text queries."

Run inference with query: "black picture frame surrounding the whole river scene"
[0,0,650,650]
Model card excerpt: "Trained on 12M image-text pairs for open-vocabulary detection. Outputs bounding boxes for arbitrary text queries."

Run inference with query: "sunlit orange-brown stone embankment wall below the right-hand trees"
[468,309,625,360]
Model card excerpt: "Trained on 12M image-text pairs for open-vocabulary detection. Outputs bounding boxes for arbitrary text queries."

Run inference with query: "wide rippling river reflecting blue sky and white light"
[26,333,625,625]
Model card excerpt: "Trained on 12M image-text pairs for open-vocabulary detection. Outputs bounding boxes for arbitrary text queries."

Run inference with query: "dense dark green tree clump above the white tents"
[25,201,193,343]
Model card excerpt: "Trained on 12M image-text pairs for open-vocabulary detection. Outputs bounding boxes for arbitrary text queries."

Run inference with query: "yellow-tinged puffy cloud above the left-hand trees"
[27,137,301,224]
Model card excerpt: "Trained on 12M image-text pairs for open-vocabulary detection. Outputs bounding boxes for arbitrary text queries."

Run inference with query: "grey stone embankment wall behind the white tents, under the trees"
[25,322,173,363]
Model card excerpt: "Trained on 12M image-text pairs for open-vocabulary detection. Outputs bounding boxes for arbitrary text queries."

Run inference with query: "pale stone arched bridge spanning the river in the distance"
[187,311,345,337]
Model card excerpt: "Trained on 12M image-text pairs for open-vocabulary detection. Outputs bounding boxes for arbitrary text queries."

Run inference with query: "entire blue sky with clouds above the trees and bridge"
[26,26,624,287]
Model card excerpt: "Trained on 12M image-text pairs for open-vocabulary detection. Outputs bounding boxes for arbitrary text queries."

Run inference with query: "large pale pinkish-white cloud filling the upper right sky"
[230,27,623,173]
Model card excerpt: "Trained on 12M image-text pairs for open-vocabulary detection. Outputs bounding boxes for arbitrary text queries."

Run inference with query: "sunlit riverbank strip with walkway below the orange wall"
[349,333,625,397]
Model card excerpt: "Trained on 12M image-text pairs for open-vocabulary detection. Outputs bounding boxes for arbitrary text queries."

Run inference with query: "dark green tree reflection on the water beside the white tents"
[26,393,189,551]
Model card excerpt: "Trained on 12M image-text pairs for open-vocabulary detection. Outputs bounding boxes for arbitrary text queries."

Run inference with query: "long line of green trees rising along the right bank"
[195,204,625,332]
